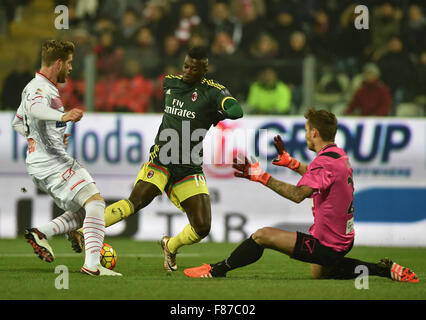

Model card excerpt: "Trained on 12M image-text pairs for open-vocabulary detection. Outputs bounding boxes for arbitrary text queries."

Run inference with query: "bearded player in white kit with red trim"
[12,40,121,276]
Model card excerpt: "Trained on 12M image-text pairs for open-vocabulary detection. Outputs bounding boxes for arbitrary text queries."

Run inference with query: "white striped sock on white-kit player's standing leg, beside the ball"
[83,200,105,268]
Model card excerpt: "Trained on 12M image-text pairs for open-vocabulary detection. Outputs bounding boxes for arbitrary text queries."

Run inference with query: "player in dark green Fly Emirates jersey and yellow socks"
[69,47,243,271]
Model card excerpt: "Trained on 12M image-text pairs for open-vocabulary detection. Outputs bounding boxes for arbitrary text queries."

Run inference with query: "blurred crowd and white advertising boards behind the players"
[0,0,426,246]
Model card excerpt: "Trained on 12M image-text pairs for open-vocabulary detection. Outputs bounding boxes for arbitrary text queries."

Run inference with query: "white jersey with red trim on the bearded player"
[16,73,74,179]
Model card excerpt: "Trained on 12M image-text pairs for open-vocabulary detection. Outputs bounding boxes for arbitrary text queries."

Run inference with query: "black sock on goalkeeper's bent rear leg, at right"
[329,258,391,279]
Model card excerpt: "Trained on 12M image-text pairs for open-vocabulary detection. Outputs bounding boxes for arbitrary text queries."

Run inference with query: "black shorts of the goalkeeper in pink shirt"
[291,232,353,267]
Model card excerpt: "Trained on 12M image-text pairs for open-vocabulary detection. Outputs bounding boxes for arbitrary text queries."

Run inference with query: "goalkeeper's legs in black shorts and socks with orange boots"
[184,228,419,283]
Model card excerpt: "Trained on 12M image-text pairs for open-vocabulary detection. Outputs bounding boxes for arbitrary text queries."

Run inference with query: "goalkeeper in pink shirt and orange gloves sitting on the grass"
[184,109,419,282]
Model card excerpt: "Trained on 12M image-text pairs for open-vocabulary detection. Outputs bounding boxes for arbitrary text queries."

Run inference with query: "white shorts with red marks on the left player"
[32,161,99,212]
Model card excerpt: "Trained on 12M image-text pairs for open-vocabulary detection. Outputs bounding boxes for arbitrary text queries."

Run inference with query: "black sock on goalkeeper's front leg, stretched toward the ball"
[210,237,264,277]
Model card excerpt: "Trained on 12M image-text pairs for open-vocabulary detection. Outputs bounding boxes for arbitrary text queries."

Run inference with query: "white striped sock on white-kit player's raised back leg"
[37,208,85,239]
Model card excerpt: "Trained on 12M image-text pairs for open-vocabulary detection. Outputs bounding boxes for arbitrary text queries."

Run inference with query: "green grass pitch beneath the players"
[0,237,426,300]
